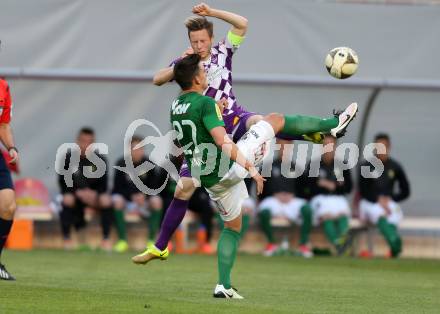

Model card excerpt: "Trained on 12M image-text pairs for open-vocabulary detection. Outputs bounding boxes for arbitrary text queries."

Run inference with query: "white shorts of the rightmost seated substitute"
[359,199,403,226]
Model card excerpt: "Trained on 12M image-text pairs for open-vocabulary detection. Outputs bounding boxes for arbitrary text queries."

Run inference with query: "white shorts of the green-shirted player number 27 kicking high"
[206,121,275,221]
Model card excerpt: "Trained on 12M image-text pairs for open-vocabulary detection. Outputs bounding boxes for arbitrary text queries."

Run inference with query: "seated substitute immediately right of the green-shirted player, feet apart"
[258,139,313,257]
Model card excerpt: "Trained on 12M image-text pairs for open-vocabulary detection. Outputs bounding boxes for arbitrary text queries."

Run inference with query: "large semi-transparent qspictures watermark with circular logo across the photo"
[55,119,386,195]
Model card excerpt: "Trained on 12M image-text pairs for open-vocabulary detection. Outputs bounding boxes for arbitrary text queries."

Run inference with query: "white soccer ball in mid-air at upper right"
[325,47,359,79]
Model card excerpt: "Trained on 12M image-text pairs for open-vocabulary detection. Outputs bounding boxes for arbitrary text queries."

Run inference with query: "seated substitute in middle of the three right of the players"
[309,136,353,254]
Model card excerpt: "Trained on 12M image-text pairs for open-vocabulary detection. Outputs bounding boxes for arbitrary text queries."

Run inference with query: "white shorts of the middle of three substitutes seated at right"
[310,195,350,226]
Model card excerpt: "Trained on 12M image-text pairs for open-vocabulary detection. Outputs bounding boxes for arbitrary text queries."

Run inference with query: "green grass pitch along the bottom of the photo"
[0,251,440,314]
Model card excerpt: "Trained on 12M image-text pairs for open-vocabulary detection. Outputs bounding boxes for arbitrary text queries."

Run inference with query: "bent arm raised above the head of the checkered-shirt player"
[192,3,248,37]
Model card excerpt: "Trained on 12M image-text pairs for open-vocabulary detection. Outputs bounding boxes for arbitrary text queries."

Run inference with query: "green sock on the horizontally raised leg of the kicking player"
[281,115,339,135]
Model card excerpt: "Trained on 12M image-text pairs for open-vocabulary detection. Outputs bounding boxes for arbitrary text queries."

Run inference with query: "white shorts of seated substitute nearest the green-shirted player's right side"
[258,196,306,224]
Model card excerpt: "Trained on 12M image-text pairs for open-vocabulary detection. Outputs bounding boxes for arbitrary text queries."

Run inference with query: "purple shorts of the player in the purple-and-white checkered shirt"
[179,106,258,178]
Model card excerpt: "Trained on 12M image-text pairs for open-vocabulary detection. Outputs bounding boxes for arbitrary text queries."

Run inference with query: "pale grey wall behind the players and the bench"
[0,0,440,216]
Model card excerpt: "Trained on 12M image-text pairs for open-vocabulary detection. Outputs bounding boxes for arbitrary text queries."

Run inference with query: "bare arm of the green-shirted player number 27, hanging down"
[209,126,266,195]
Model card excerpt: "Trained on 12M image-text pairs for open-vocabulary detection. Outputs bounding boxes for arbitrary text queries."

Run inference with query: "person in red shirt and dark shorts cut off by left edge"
[0,70,18,280]
